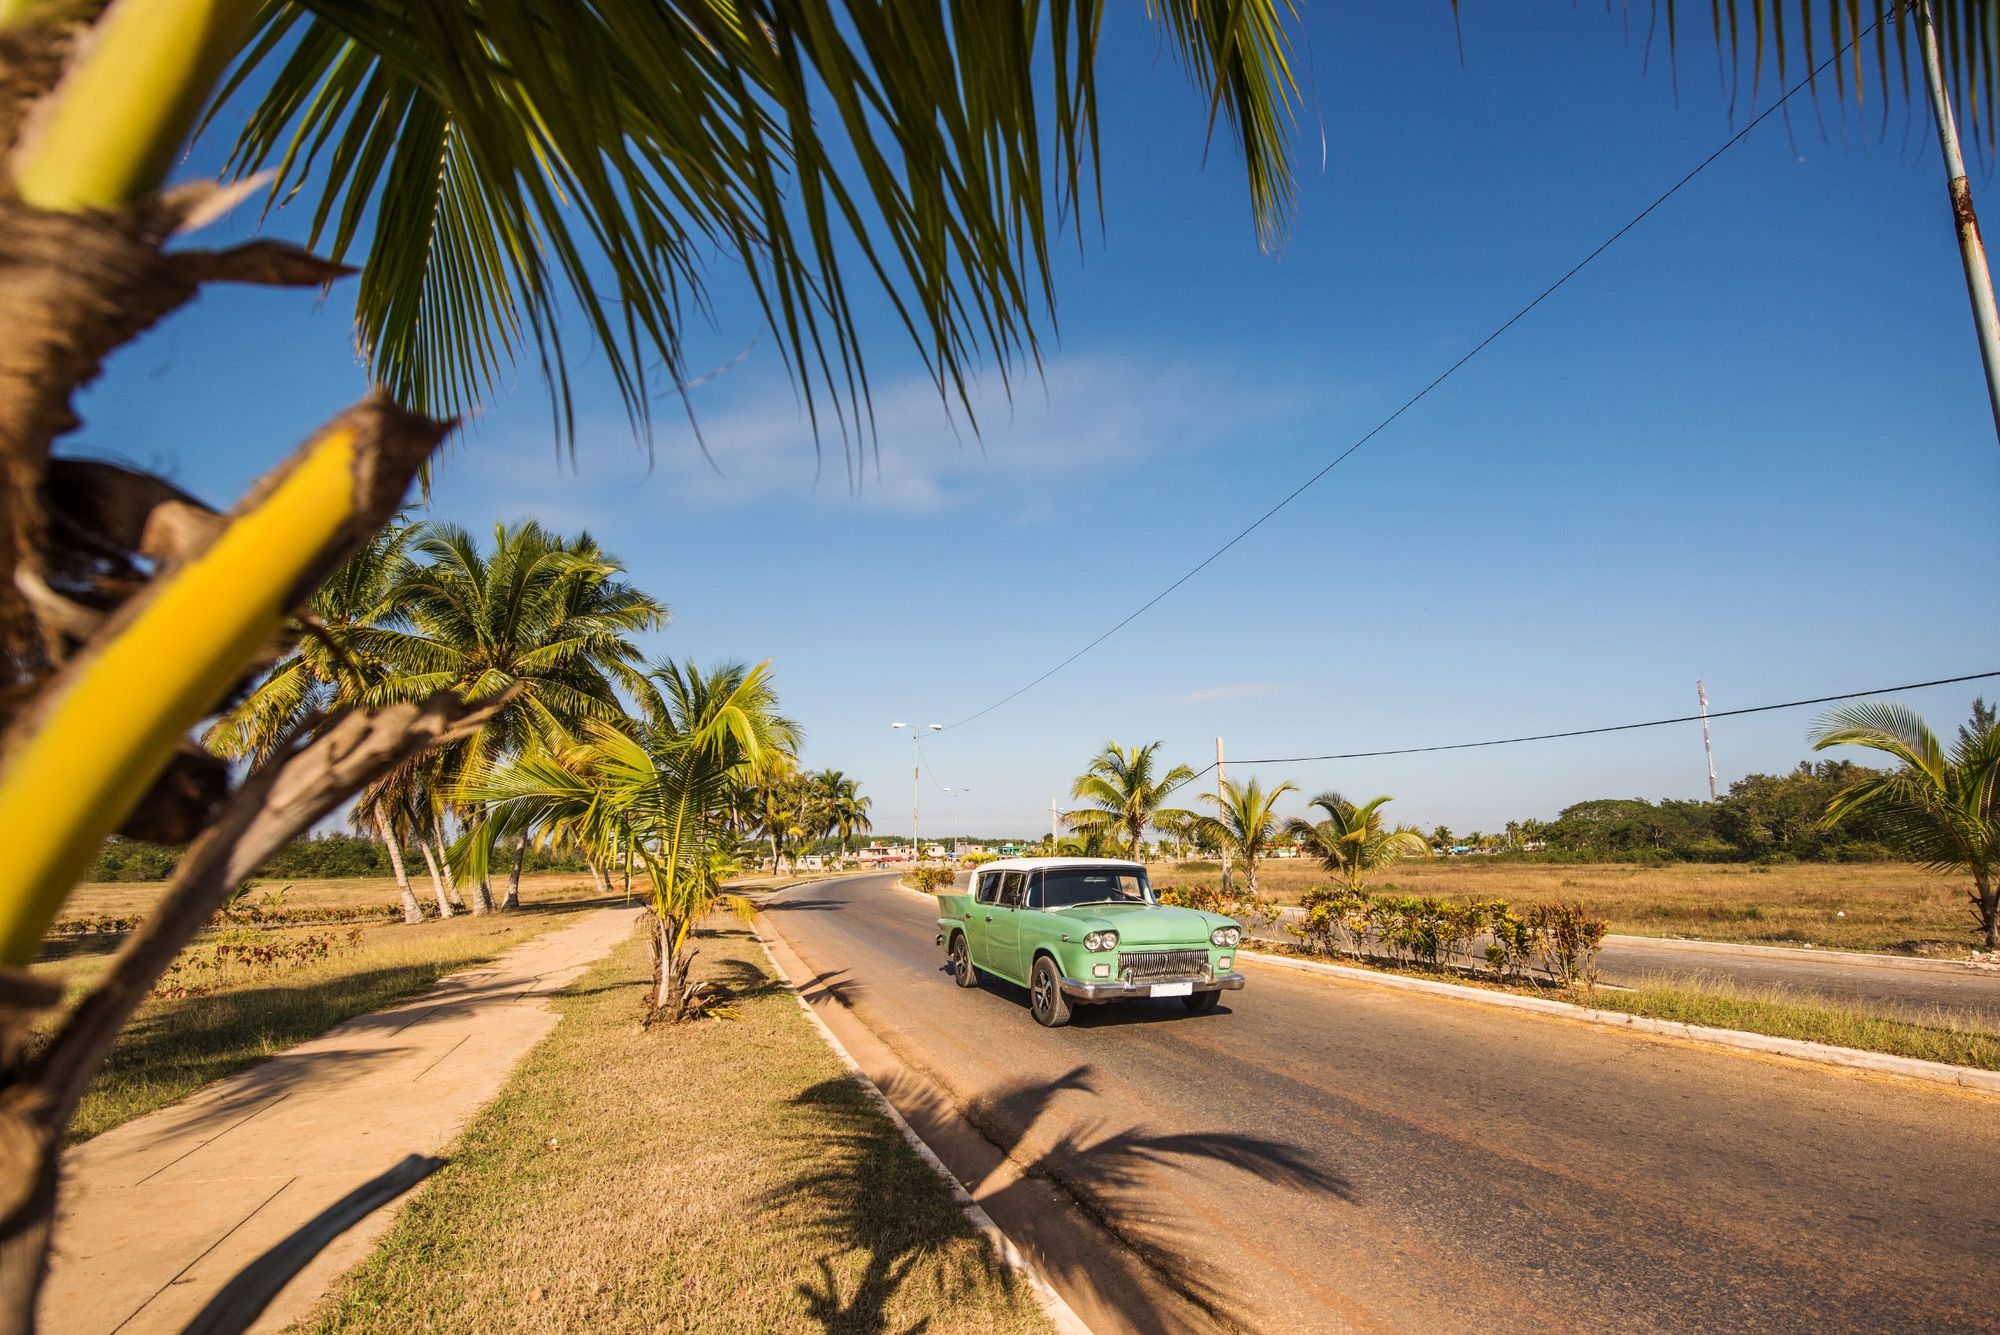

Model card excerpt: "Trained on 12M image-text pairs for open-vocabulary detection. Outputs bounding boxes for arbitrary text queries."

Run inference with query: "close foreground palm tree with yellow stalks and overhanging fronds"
[0,0,1296,1323]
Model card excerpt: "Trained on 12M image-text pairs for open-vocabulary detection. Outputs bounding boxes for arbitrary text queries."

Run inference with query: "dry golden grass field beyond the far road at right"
[1152,857,1976,955]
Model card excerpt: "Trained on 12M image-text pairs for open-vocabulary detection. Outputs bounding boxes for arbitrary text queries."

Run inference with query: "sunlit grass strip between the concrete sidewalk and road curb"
[304,929,1048,1335]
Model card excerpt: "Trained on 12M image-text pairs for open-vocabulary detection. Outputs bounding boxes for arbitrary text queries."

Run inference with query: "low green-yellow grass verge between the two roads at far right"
[1578,979,2000,1071]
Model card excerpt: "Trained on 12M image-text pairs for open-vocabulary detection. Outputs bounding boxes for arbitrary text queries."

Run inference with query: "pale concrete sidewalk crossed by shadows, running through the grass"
[40,907,634,1335]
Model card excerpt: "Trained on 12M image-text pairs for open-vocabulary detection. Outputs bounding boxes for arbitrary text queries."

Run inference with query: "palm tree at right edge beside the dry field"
[1812,699,2000,949]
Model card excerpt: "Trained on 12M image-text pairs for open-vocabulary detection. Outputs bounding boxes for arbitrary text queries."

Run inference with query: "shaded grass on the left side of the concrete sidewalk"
[36,911,578,1141]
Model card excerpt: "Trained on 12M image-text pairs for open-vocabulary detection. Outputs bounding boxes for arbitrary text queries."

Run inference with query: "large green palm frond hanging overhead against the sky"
[224,0,1296,453]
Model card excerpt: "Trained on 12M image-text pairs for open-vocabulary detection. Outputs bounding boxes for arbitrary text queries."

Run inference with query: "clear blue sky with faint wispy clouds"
[74,0,2000,833]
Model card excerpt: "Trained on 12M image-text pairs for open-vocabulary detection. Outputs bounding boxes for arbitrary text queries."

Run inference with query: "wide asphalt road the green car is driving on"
[764,875,2000,1331]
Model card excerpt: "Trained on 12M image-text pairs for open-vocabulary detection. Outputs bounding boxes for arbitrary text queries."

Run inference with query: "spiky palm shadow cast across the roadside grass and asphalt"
[774,1065,1354,1333]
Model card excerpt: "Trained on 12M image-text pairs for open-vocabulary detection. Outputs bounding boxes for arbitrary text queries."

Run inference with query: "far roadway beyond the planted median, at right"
[1262,909,2000,1029]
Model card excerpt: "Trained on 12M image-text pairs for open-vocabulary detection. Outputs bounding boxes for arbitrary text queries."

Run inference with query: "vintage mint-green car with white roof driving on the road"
[938,857,1244,1027]
